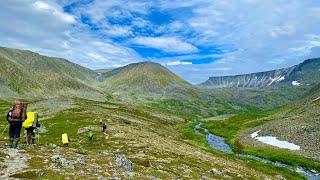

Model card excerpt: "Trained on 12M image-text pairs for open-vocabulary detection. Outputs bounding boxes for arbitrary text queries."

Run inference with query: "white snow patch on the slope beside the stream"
[251,130,300,150]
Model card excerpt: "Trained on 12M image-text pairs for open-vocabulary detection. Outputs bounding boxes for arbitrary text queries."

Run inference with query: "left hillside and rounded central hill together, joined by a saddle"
[0,48,254,119]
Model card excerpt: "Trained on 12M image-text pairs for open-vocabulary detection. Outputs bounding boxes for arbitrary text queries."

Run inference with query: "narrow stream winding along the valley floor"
[194,123,320,180]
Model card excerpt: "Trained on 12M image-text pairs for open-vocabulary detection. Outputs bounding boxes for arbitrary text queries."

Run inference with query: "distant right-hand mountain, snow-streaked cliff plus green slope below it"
[199,58,320,109]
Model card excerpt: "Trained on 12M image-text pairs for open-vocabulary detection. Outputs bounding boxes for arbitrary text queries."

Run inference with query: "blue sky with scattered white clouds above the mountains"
[0,0,320,83]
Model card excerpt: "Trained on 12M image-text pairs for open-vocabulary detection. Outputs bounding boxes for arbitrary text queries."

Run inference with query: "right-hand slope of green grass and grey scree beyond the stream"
[204,85,320,170]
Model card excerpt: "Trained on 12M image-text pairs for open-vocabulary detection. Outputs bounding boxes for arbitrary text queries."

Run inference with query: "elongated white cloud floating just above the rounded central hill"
[133,37,198,53]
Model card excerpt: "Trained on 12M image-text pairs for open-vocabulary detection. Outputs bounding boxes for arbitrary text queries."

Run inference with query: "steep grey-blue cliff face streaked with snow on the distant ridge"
[201,58,320,88]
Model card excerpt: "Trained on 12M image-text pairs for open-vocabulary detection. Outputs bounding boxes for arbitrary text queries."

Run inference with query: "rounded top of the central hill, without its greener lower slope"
[101,62,196,98]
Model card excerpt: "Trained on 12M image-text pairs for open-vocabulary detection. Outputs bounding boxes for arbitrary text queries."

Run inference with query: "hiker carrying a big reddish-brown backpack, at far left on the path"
[7,101,27,148]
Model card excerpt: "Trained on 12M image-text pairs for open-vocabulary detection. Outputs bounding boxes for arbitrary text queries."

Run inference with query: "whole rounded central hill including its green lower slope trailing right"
[100,62,255,120]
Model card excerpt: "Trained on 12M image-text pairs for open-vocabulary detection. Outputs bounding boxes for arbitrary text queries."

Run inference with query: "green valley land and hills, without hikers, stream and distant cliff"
[0,48,320,179]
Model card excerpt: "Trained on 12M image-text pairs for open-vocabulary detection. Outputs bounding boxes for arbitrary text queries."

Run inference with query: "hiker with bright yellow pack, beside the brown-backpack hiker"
[22,112,40,145]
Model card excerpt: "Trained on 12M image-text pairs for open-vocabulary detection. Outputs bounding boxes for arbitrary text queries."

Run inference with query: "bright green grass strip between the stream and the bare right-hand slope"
[203,107,320,171]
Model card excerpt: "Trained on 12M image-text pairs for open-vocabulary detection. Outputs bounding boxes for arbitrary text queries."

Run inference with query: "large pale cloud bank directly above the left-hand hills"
[0,0,141,68]
